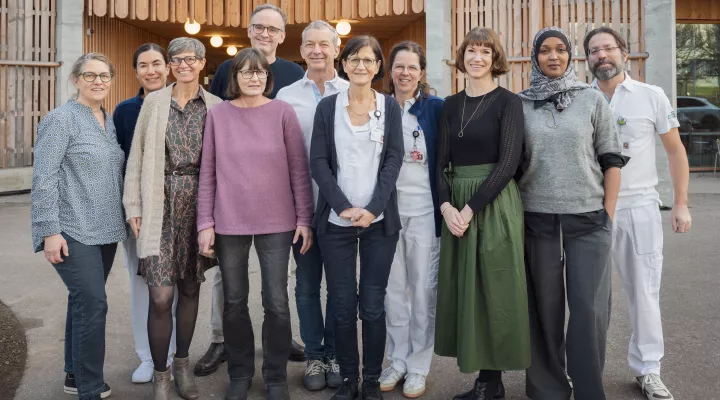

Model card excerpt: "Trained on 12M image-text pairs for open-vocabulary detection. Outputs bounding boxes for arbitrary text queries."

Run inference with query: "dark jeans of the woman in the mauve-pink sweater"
[215,232,295,385]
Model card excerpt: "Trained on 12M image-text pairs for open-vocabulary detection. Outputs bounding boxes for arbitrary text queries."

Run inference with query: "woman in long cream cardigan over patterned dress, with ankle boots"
[123,37,222,400]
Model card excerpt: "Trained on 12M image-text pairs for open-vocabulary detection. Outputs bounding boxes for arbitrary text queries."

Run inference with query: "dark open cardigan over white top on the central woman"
[310,94,404,236]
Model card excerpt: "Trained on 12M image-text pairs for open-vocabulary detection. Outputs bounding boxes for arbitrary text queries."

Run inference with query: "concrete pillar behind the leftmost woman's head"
[55,0,85,106]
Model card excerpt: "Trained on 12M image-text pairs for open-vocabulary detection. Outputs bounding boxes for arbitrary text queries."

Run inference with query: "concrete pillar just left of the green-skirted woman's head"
[425,0,455,97]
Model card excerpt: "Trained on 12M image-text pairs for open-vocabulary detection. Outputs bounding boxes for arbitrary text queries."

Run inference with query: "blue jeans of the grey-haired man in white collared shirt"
[293,231,335,360]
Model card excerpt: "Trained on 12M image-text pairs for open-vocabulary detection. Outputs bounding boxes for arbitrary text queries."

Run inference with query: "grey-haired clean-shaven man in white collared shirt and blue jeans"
[276,20,349,390]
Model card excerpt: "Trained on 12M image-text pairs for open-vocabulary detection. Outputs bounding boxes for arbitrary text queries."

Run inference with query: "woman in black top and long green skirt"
[435,28,530,400]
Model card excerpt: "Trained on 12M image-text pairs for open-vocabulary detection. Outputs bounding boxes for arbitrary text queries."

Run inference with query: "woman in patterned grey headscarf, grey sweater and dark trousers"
[519,27,626,400]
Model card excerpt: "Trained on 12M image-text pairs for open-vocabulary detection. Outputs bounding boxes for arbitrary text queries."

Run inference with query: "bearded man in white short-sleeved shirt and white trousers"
[584,27,691,400]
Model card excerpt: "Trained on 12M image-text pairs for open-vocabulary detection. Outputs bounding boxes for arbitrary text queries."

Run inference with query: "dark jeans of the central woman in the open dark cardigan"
[318,223,398,381]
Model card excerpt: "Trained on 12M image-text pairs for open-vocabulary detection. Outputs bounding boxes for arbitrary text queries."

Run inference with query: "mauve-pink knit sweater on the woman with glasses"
[197,100,313,235]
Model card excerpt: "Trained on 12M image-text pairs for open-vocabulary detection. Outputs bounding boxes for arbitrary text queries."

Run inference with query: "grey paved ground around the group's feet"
[0,174,720,400]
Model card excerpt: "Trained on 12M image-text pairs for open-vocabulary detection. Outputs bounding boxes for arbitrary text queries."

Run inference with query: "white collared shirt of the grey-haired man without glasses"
[275,71,350,206]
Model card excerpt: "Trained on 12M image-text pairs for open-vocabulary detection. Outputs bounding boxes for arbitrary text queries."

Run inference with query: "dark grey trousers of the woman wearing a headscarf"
[525,211,612,400]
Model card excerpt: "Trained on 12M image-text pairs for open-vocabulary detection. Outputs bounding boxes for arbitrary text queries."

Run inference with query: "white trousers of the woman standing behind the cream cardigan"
[123,238,177,365]
